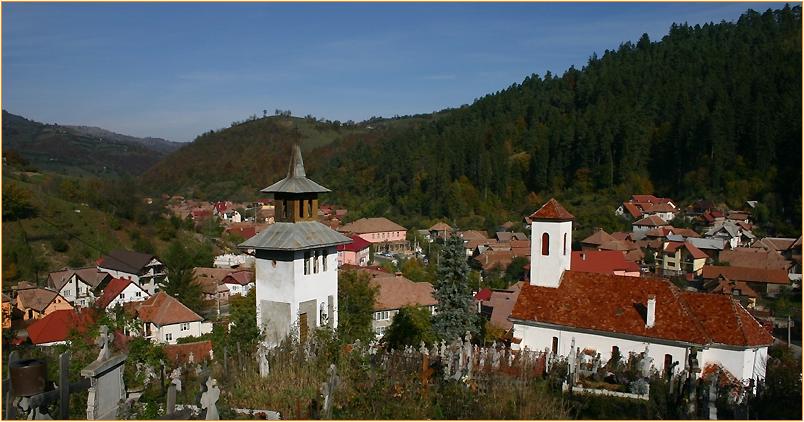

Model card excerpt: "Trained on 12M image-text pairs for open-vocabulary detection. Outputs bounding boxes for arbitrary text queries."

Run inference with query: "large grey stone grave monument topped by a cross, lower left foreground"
[81,325,126,419]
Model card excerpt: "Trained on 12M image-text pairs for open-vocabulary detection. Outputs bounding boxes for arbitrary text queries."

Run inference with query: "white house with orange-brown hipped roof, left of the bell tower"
[128,292,212,344]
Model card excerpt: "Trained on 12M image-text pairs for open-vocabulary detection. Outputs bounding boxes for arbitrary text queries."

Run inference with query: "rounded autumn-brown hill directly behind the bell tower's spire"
[143,115,446,200]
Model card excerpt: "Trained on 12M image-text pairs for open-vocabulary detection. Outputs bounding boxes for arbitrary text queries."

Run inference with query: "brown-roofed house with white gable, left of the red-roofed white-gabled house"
[47,267,112,308]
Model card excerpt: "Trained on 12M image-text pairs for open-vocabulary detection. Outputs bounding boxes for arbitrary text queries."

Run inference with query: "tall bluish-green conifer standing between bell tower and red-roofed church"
[433,236,477,341]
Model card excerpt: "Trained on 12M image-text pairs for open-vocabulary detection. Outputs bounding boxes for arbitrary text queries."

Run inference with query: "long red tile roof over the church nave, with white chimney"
[511,271,772,345]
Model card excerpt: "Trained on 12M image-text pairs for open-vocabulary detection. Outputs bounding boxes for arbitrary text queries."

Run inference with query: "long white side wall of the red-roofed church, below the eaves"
[514,324,688,373]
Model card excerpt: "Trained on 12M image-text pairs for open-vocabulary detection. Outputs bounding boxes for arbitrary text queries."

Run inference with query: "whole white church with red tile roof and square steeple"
[510,199,773,380]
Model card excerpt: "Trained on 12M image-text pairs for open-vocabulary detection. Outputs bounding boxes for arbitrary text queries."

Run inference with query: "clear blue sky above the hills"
[2,2,784,141]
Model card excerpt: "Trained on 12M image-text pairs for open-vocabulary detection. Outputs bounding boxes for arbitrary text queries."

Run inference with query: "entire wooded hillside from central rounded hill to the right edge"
[147,6,801,232]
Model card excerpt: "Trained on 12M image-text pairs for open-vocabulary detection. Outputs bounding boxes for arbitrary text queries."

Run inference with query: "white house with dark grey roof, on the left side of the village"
[97,249,167,294]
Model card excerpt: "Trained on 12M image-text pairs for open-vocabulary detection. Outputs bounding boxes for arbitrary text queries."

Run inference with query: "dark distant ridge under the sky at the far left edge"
[3,110,180,177]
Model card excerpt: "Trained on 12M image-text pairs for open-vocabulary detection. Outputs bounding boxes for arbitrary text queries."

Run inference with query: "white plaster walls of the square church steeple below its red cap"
[530,221,572,287]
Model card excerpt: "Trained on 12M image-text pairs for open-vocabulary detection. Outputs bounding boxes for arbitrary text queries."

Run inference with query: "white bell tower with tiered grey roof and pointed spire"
[239,145,352,347]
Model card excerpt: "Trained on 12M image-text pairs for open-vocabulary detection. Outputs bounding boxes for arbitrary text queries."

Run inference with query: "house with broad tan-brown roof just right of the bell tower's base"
[346,266,438,338]
